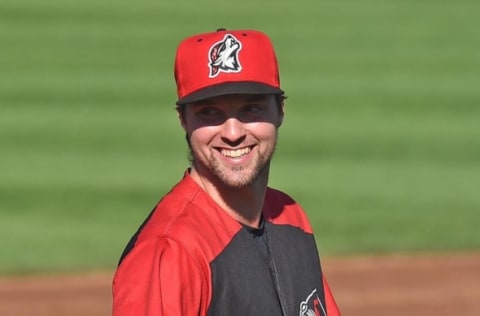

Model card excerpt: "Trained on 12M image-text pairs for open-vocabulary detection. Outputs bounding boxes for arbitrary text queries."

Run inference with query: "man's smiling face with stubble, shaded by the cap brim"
[180,95,283,188]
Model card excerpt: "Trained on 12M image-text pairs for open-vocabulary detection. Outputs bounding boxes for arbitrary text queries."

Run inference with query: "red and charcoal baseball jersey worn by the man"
[113,173,340,316]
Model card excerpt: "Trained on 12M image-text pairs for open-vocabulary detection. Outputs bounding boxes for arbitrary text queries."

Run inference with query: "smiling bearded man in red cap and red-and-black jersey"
[113,29,340,316]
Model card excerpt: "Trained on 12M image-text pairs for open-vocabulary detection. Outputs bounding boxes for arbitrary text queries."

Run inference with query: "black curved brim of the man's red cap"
[177,82,284,105]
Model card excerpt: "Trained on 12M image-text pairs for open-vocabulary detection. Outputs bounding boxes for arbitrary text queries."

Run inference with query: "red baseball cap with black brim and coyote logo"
[175,29,284,105]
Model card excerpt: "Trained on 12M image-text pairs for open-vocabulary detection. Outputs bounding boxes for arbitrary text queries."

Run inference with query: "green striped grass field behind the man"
[0,0,480,274]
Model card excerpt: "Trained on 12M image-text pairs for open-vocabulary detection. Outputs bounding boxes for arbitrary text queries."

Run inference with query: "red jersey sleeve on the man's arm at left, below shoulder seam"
[113,238,209,316]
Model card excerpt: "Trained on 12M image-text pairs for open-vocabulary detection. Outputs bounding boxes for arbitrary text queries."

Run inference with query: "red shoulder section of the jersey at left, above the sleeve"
[123,178,241,262]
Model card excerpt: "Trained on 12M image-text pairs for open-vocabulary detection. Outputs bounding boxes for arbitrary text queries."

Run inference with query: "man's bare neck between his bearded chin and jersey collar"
[191,166,269,228]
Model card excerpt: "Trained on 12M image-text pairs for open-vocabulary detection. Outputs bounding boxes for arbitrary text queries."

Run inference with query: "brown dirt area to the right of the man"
[324,253,480,316]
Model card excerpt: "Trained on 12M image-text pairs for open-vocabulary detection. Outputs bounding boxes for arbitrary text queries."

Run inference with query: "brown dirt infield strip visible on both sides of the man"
[0,253,480,316]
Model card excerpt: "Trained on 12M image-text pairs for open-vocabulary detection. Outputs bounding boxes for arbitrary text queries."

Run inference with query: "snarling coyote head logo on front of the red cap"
[208,34,242,78]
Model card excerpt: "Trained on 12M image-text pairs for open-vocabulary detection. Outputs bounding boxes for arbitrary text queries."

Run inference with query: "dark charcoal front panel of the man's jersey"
[208,223,325,316]
